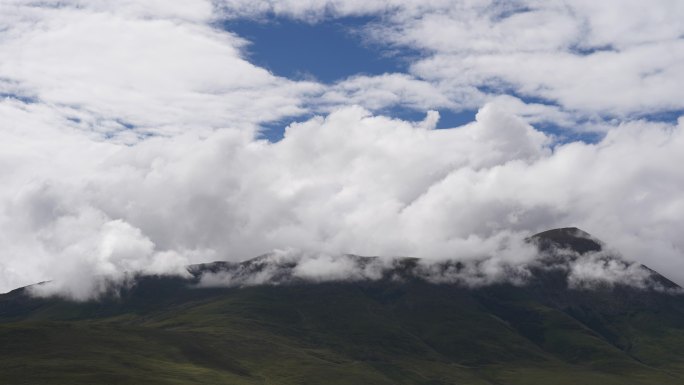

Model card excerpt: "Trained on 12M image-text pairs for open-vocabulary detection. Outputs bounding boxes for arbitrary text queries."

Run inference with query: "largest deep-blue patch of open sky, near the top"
[222,17,417,83]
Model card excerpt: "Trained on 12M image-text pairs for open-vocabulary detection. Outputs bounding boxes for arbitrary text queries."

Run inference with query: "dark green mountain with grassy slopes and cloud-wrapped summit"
[0,228,684,385]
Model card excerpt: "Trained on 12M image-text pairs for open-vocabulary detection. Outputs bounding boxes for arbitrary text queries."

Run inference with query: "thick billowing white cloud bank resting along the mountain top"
[0,104,684,298]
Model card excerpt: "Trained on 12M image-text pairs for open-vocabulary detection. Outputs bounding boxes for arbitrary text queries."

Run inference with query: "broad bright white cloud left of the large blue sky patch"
[0,2,319,140]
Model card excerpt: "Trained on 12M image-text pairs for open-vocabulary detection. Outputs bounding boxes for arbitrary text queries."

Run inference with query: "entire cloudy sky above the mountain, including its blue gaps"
[0,0,684,298]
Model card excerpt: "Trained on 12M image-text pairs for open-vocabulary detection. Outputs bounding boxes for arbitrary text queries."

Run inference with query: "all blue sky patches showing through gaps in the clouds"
[219,13,684,143]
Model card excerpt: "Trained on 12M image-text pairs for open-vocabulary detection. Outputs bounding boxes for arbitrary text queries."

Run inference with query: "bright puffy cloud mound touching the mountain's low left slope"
[29,210,188,300]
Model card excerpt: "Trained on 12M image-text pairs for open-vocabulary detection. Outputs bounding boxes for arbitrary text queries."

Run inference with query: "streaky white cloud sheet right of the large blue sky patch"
[390,0,684,117]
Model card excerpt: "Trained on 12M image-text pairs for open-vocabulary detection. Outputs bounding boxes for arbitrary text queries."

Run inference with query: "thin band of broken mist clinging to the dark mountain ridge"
[190,240,680,293]
